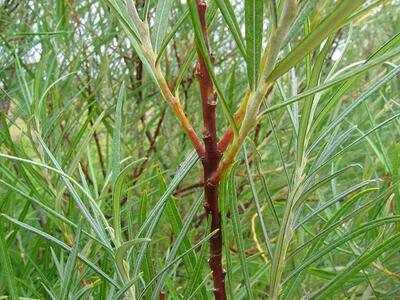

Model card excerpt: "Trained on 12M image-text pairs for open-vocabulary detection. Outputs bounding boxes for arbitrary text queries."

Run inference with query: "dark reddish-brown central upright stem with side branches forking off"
[196,0,226,300]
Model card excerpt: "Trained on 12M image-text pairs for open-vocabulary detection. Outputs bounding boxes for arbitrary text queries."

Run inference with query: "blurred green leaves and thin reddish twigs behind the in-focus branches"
[0,0,400,299]
